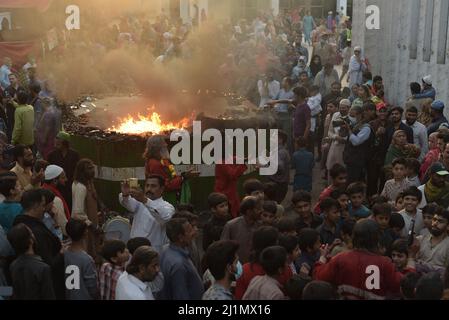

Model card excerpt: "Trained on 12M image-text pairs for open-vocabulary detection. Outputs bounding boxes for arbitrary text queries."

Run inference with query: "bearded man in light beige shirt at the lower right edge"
[416,208,449,272]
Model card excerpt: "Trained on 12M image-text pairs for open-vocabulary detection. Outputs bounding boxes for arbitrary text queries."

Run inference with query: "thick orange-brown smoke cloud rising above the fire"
[41,0,237,120]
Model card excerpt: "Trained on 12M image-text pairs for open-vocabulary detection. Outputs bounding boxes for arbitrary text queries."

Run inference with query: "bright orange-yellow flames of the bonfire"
[108,112,189,135]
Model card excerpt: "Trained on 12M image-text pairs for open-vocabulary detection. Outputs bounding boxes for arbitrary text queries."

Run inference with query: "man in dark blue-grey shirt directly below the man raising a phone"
[158,218,204,300]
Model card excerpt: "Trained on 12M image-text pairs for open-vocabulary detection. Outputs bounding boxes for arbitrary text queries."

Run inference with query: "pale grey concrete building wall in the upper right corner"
[353,0,449,115]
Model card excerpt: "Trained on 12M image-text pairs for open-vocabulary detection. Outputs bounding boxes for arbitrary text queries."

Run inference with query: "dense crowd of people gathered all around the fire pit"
[0,7,449,300]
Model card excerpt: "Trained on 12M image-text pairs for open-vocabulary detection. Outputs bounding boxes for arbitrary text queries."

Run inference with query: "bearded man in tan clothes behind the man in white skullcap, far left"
[11,145,44,190]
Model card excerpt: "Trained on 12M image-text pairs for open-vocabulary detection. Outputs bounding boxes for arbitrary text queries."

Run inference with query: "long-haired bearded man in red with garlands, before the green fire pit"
[144,135,199,205]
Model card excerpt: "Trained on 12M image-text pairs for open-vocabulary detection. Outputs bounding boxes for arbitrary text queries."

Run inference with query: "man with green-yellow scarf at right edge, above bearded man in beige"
[418,162,449,209]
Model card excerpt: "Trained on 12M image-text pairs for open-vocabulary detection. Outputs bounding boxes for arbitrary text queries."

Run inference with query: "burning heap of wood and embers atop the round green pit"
[63,94,275,141]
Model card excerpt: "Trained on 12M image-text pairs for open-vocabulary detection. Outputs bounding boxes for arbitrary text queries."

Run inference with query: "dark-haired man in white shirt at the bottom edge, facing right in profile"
[115,246,160,300]
